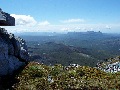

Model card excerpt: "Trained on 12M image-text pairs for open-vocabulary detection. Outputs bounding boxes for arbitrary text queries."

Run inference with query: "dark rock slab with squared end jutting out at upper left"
[0,8,15,26]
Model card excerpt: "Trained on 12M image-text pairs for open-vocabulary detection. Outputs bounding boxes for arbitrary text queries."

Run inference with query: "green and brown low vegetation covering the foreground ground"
[13,62,120,90]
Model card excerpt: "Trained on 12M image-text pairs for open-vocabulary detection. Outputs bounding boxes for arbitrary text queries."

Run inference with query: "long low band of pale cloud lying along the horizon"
[4,24,120,33]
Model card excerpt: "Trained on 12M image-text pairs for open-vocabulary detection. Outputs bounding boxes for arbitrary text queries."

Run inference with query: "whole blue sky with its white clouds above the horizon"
[0,0,120,33]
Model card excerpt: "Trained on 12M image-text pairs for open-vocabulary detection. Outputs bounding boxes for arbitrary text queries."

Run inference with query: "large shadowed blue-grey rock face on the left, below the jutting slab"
[0,28,29,76]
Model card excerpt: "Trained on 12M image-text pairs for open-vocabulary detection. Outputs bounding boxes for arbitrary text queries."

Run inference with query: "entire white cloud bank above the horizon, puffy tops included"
[5,14,120,33]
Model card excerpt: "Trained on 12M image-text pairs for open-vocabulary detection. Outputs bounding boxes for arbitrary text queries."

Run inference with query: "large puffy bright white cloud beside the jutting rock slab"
[11,14,37,26]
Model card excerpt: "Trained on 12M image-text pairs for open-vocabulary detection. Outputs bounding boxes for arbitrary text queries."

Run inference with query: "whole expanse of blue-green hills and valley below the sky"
[16,31,120,66]
